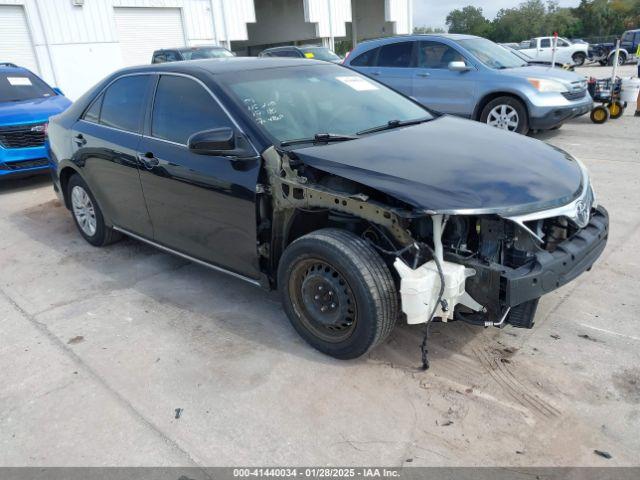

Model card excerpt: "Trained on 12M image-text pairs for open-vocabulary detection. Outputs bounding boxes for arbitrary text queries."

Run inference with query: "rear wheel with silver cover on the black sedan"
[67,174,121,247]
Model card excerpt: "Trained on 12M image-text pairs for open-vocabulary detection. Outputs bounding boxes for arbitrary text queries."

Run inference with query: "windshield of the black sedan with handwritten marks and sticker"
[218,63,431,142]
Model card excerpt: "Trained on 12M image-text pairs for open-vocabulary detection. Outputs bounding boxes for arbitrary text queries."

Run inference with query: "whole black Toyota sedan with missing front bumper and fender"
[48,58,608,359]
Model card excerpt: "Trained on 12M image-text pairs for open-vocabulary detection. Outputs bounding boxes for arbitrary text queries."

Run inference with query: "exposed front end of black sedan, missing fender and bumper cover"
[259,148,608,328]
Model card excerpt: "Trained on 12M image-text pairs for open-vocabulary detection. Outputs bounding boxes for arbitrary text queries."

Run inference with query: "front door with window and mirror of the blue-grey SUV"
[413,40,478,117]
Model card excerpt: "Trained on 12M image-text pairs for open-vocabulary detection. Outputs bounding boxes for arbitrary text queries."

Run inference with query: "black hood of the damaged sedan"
[293,116,583,215]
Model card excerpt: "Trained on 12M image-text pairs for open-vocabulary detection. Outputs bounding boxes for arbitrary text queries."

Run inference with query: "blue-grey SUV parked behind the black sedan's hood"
[344,34,593,134]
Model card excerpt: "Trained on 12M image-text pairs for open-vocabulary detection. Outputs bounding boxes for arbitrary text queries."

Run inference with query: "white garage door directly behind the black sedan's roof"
[114,7,185,66]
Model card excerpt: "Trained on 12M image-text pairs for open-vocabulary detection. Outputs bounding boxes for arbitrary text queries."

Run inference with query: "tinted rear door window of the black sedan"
[100,75,150,133]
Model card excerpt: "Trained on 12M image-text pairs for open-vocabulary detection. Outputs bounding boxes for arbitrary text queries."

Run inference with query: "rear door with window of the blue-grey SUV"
[359,41,416,96]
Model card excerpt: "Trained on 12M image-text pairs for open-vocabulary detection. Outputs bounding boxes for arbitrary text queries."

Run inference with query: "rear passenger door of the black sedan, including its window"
[72,75,153,238]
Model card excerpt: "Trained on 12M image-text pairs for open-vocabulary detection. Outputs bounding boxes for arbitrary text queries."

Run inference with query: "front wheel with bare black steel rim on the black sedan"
[278,228,399,360]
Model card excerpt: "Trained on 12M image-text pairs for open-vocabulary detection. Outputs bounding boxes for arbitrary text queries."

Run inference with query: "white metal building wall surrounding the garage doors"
[0,0,255,99]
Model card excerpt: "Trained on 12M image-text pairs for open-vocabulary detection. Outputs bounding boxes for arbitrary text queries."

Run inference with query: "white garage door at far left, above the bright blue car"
[0,5,39,73]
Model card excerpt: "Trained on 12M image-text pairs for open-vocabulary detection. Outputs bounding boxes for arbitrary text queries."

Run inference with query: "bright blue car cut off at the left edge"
[0,63,71,178]
